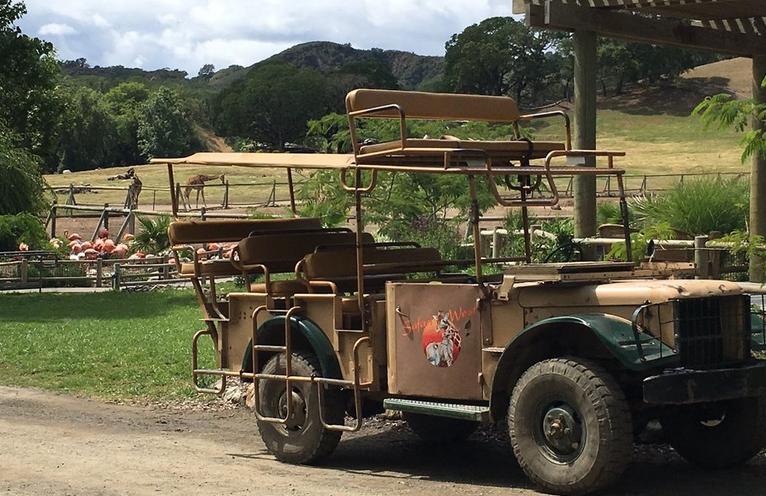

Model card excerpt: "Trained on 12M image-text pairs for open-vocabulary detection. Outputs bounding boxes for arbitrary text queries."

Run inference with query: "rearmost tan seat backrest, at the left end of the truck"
[168,218,322,245]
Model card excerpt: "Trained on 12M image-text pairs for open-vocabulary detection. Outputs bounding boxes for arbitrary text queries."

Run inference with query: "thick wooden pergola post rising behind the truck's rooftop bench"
[574,31,598,259]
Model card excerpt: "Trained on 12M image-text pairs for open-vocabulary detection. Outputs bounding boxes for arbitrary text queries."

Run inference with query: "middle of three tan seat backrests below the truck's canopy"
[238,230,375,273]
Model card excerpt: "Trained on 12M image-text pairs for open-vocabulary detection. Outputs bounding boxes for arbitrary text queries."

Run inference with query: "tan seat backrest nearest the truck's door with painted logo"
[303,247,442,280]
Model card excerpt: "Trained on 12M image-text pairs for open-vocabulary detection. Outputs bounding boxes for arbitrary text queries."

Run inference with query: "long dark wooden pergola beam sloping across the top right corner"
[526,1,766,57]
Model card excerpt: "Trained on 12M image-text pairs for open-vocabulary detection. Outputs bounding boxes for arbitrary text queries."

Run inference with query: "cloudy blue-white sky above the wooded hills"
[19,0,512,75]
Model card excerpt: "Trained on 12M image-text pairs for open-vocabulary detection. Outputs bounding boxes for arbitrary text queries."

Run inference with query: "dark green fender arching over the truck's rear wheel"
[242,316,343,379]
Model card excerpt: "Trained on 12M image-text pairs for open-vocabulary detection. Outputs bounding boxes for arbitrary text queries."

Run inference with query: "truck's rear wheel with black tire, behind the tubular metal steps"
[257,351,344,464]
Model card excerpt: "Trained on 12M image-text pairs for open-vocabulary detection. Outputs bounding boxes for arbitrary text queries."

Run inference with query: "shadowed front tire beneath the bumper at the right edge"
[662,398,766,469]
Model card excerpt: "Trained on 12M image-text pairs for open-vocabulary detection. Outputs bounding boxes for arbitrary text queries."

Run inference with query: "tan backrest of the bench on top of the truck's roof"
[346,89,520,122]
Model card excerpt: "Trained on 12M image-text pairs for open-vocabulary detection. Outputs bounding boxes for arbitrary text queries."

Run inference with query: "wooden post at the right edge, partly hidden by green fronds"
[750,55,766,282]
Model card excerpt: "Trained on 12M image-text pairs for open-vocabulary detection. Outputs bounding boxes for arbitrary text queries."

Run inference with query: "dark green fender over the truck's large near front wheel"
[504,313,676,371]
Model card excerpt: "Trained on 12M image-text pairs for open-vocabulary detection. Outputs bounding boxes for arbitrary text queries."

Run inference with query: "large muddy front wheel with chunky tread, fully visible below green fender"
[508,358,633,495]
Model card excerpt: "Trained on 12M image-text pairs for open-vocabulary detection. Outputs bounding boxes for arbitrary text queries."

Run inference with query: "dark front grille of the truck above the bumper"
[673,295,751,369]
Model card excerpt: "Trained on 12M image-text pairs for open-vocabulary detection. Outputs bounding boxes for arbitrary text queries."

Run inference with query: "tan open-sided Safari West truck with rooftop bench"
[155,89,766,494]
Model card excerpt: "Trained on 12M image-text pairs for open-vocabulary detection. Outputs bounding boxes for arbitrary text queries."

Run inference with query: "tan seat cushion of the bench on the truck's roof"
[357,138,565,161]
